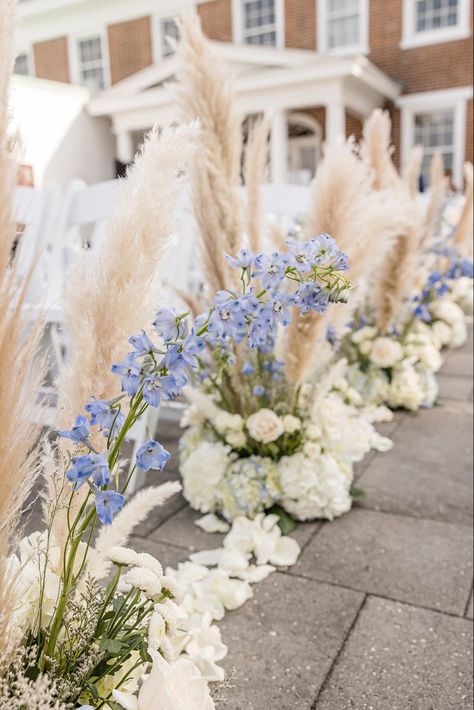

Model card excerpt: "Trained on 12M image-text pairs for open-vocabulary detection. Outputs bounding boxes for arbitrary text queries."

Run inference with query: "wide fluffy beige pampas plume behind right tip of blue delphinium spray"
[284,143,406,383]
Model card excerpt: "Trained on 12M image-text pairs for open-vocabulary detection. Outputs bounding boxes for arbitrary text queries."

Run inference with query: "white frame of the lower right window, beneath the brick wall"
[397,86,472,188]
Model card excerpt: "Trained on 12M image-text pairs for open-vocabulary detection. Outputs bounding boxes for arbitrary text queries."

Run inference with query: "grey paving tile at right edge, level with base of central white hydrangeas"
[357,454,473,525]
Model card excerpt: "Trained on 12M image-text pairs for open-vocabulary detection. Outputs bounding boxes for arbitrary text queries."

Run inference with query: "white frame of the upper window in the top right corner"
[400,0,471,49]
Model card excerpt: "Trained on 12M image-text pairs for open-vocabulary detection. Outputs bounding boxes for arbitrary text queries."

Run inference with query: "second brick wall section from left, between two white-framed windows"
[107,17,153,84]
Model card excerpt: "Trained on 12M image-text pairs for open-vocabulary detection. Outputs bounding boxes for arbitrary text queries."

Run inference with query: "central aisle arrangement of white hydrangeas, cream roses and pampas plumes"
[172,19,404,529]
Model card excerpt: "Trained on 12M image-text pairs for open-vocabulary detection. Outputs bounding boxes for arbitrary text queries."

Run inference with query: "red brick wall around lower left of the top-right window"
[369,0,472,93]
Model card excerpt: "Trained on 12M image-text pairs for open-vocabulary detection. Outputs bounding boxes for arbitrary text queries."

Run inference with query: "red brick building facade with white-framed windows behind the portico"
[17,0,473,184]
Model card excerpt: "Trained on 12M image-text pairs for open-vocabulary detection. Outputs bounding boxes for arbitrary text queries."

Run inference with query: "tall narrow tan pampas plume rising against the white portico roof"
[176,15,243,292]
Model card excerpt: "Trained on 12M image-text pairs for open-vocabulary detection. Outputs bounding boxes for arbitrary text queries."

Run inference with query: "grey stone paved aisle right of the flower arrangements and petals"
[135,330,473,710]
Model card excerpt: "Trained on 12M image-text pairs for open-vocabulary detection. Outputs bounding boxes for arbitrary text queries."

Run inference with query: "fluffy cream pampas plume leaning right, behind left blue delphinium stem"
[53,123,198,546]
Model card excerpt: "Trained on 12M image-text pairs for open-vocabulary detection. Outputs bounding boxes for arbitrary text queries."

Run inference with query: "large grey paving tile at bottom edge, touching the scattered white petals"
[218,573,363,710]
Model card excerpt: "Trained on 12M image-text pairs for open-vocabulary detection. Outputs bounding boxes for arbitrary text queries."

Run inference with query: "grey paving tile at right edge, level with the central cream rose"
[388,401,472,469]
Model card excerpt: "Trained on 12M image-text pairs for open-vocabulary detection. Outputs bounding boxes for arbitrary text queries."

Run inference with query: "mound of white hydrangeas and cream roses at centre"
[181,382,391,521]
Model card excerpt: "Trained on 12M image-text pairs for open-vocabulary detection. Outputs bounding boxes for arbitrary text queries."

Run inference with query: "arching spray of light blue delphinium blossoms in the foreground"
[59,234,349,524]
